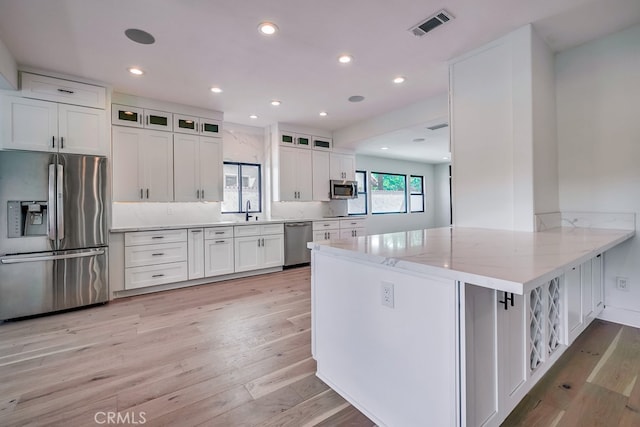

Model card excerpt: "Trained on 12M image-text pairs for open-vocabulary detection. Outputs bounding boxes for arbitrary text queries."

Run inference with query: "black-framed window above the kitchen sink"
[222,162,262,213]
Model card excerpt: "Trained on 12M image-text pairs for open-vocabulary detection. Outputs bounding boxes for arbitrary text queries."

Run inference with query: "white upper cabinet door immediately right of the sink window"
[280,147,313,202]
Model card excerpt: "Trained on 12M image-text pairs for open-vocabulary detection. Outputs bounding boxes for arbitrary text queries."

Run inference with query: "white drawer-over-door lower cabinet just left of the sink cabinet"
[204,227,235,277]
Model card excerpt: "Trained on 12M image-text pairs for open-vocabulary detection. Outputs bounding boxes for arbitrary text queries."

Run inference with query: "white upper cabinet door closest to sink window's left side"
[198,137,223,202]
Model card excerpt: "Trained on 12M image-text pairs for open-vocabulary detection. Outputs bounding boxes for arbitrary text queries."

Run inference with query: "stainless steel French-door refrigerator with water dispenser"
[0,151,108,320]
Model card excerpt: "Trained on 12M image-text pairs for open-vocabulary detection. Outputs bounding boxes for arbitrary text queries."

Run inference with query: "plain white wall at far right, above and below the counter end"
[555,25,640,325]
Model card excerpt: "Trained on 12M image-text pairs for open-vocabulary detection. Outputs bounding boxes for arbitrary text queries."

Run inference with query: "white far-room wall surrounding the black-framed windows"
[356,155,449,234]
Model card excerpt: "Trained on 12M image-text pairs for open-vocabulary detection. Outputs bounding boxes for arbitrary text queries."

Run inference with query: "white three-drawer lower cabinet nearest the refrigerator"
[124,230,188,289]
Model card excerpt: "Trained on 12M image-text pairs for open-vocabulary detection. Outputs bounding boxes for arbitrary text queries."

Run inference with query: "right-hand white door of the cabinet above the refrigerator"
[58,104,109,156]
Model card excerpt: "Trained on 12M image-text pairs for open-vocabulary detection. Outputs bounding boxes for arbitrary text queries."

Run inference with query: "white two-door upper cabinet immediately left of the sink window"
[173,133,222,202]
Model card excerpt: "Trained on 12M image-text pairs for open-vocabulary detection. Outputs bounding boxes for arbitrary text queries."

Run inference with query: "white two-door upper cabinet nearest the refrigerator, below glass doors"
[113,126,173,202]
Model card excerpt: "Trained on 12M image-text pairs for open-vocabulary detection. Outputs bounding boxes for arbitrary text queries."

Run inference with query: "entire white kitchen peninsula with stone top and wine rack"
[309,227,634,426]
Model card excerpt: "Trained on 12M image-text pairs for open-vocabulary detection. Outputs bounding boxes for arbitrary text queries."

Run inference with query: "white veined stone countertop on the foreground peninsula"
[308,227,634,294]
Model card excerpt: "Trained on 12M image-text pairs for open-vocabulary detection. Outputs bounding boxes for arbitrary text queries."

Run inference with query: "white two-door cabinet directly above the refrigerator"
[2,96,109,155]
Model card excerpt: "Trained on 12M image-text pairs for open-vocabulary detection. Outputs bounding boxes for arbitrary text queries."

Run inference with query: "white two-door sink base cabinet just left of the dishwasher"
[233,224,284,273]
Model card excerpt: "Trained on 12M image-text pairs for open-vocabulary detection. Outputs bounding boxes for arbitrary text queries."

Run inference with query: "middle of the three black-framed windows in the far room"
[371,172,407,214]
